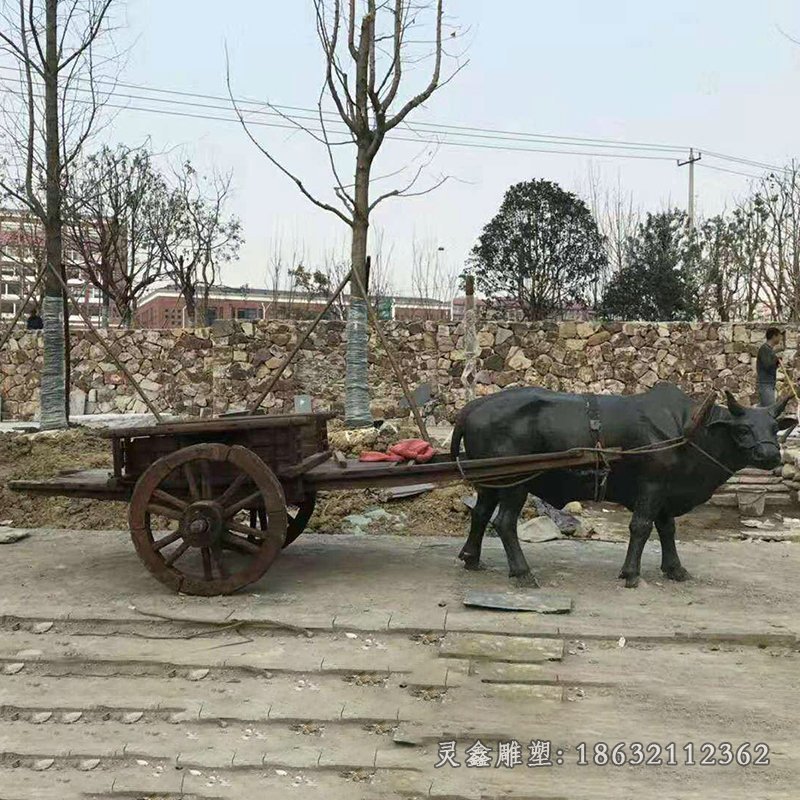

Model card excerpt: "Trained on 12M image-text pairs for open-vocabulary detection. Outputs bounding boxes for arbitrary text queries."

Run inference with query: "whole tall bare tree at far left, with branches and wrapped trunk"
[0,0,113,429]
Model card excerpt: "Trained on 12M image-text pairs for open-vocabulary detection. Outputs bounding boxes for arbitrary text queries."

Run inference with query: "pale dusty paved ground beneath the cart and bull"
[0,528,800,800]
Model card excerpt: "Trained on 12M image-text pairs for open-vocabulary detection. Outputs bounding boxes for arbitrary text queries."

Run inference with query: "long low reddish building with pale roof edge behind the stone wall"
[136,286,450,328]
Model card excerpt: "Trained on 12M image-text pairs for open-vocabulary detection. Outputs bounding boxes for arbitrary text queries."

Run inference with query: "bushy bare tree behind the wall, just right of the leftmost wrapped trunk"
[67,145,166,327]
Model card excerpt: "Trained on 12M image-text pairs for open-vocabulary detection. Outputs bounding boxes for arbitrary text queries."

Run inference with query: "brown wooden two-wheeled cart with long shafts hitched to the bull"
[9,414,615,595]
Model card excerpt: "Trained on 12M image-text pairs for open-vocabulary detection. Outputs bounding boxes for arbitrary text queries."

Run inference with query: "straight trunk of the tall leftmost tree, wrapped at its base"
[40,0,68,430]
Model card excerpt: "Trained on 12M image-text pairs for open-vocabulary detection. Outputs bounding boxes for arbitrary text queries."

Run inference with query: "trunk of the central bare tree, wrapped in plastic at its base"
[344,146,372,428]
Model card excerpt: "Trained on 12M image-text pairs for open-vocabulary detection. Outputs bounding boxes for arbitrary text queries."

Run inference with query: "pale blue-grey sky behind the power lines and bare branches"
[103,0,800,291]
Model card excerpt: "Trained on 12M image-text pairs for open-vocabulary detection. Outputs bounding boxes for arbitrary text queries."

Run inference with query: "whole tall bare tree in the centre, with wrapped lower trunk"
[228,0,463,427]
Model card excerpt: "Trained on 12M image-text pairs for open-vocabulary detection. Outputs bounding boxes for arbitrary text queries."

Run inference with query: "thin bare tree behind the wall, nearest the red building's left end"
[155,161,242,326]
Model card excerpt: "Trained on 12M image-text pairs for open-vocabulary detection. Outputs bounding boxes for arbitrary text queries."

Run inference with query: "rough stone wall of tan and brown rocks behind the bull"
[0,321,800,421]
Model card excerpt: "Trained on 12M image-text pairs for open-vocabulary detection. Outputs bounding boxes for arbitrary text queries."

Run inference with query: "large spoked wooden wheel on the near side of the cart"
[128,444,288,595]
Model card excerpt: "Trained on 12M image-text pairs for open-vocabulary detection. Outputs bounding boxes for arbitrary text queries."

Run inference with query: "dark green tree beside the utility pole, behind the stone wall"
[601,209,701,322]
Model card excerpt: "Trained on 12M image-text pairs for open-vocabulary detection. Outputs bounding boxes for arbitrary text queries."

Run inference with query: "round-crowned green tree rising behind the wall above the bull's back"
[470,180,607,320]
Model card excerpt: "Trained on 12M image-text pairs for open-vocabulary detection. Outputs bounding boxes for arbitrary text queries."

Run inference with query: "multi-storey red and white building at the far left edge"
[0,209,124,327]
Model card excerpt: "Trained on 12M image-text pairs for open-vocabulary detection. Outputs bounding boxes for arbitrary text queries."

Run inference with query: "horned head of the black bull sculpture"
[709,390,795,469]
